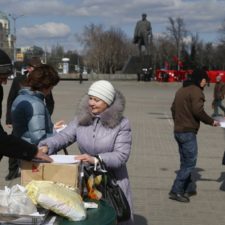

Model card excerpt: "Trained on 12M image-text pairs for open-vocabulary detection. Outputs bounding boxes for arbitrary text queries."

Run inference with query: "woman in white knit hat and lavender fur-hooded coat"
[39,80,133,225]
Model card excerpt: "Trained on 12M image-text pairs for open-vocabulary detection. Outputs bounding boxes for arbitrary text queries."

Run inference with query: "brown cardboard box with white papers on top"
[21,161,79,188]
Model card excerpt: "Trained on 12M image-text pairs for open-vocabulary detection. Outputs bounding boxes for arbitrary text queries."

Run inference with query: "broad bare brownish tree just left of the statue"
[78,24,136,74]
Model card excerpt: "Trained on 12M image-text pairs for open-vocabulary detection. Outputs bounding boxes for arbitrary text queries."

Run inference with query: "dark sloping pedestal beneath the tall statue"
[122,55,152,74]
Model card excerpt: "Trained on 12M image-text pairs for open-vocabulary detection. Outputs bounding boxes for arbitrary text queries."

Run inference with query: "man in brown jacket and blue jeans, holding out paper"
[169,69,219,202]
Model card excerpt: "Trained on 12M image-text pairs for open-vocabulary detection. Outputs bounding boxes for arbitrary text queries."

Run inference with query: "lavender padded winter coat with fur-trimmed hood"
[39,91,133,225]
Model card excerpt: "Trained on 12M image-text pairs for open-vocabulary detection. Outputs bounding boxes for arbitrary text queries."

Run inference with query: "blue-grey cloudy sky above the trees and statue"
[0,0,225,50]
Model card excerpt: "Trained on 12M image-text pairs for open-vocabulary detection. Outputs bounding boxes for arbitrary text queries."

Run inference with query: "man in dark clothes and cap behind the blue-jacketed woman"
[5,56,54,180]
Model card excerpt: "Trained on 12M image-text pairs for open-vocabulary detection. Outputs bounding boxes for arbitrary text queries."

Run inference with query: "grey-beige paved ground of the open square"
[0,78,225,225]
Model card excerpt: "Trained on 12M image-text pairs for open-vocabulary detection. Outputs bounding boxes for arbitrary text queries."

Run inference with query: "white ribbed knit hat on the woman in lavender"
[88,80,116,105]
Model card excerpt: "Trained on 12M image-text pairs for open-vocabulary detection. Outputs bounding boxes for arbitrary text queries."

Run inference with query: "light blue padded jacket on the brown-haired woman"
[11,88,53,145]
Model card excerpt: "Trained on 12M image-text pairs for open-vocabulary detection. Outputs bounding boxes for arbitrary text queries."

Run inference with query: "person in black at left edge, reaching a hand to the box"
[0,49,52,162]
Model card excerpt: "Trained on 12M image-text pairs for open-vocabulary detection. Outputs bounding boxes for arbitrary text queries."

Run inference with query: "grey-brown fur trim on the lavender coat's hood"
[77,90,125,128]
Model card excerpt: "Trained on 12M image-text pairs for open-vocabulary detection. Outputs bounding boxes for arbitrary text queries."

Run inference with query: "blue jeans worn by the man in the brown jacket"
[171,132,198,194]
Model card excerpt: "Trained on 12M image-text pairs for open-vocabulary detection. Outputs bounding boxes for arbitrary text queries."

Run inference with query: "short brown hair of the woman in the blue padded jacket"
[25,64,60,91]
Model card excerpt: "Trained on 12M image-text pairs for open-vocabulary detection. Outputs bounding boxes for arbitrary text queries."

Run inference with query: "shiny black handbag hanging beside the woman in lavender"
[84,160,131,222]
